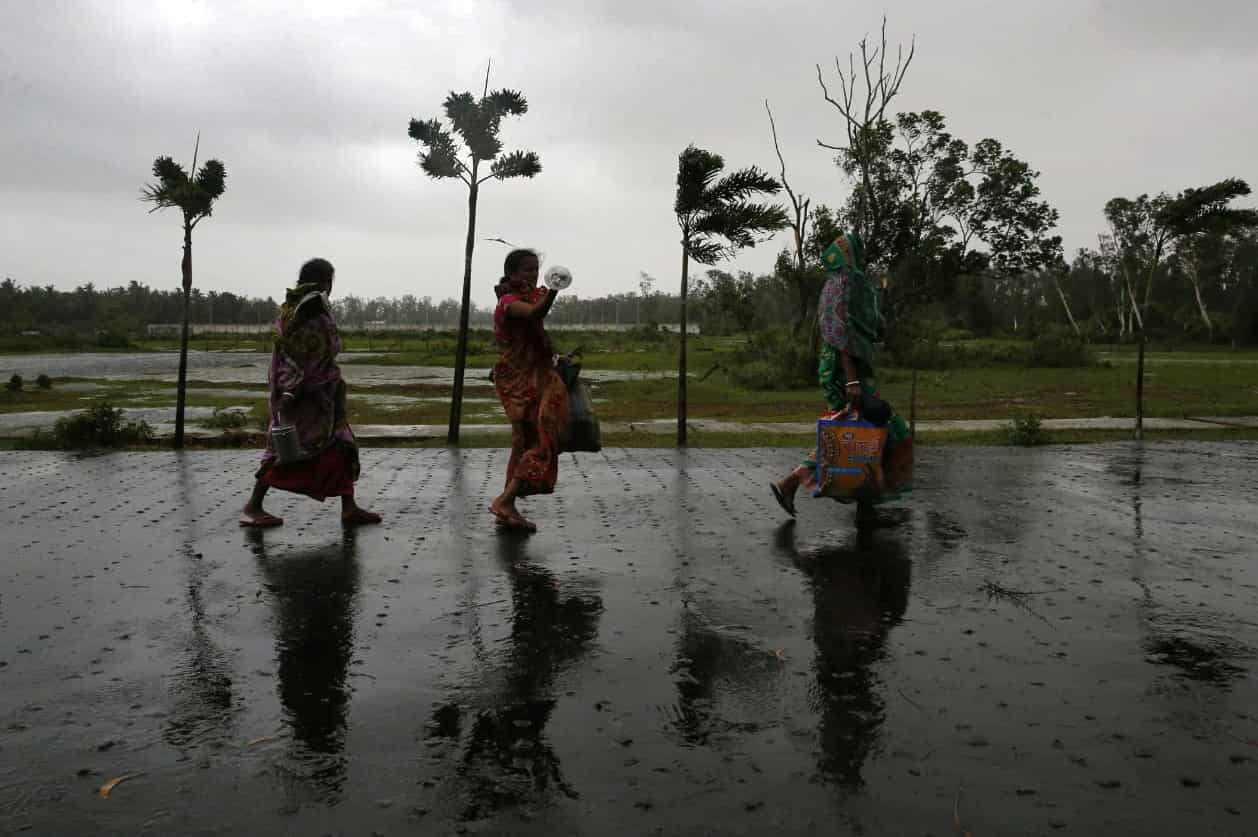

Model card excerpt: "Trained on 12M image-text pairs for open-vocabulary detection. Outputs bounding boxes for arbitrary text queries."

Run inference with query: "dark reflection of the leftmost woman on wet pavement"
[245,529,360,802]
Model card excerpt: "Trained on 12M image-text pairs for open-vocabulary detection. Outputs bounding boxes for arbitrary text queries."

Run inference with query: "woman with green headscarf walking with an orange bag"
[770,233,913,517]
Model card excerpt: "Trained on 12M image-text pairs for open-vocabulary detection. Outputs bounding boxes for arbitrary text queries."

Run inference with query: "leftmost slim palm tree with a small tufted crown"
[140,133,228,451]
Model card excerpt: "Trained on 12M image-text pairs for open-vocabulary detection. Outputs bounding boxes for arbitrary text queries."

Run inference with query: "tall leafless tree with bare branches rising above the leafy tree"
[816,15,917,262]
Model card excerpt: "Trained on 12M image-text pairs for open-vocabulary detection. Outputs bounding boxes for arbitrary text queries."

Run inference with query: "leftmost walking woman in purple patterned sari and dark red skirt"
[240,259,380,526]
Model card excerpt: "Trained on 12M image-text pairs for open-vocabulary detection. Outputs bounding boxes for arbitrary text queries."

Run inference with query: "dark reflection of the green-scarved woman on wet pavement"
[774,516,912,789]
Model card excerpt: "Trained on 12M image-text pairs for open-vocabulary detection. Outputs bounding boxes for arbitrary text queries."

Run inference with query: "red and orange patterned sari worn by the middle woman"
[493,282,567,497]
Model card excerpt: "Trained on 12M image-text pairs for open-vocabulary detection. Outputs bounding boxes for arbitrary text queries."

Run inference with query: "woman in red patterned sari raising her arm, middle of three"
[489,250,567,531]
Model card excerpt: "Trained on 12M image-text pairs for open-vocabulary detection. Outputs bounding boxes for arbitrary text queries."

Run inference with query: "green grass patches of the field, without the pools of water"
[0,331,1258,447]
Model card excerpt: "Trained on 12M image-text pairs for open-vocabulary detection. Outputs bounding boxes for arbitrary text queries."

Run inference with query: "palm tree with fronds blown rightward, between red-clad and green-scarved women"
[673,145,788,447]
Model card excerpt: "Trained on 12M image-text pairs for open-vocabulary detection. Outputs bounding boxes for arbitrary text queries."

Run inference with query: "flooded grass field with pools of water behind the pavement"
[0,332,1258,439]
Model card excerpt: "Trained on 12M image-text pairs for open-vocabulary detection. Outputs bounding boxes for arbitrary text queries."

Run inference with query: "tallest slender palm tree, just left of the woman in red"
[409,70,542,444]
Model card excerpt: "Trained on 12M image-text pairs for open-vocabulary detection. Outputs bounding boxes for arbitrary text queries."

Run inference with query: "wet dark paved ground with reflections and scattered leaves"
[0,443,1258,837]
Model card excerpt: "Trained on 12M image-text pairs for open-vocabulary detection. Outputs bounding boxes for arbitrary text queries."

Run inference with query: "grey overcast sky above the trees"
[0,0,1258,303]
